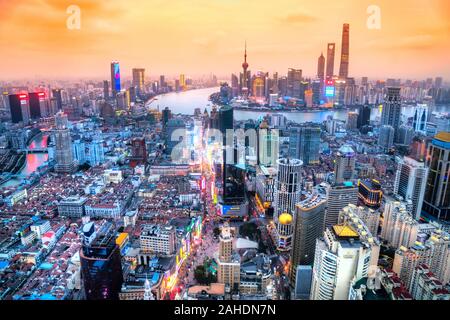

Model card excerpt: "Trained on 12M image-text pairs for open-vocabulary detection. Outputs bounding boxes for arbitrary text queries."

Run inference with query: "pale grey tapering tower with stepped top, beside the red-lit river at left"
[55,111,77,173]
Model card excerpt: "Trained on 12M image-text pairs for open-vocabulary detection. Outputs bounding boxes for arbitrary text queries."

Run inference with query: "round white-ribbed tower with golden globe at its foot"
[274,158,303,251]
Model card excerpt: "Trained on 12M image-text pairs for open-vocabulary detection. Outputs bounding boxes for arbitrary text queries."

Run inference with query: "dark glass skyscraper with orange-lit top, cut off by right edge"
[422,132,450,221]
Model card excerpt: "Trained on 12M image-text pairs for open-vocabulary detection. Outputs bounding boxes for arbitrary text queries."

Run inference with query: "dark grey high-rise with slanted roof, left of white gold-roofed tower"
[289,187,327,287]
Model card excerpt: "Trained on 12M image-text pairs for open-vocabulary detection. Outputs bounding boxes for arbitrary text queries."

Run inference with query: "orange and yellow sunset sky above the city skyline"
[0,0,450,80]
